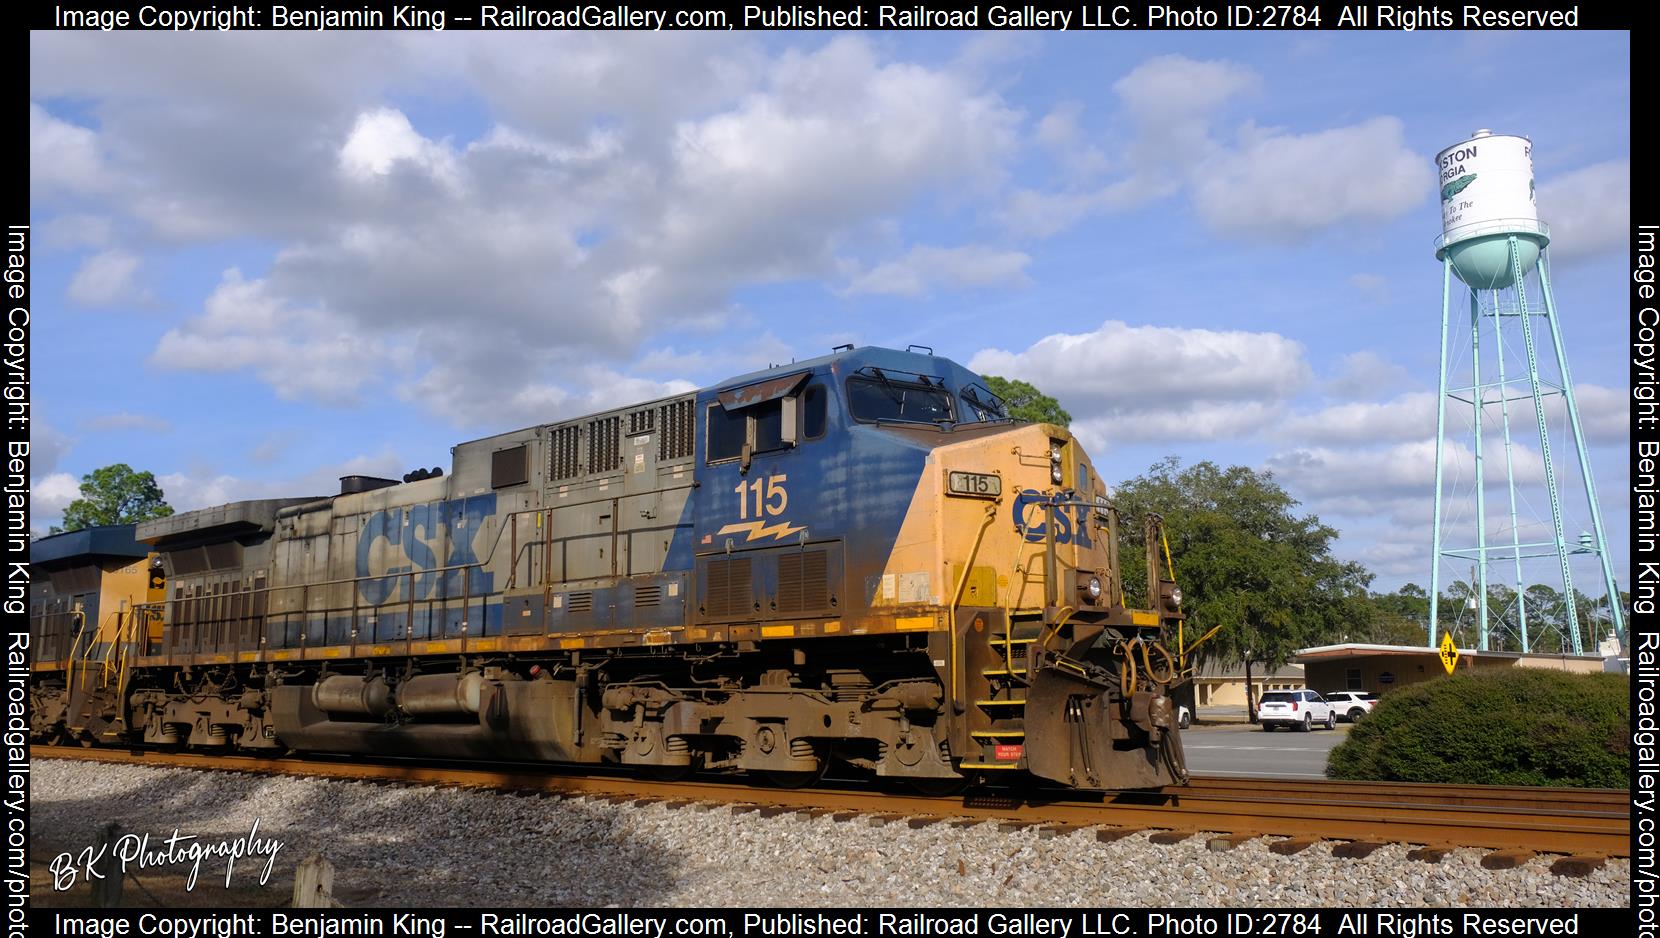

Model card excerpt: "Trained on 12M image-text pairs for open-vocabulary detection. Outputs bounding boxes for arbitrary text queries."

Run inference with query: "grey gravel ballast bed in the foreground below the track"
[30,760,1630,908]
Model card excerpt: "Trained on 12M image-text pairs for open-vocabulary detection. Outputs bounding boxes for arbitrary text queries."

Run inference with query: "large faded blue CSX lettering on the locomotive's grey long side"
[357,493,496,606]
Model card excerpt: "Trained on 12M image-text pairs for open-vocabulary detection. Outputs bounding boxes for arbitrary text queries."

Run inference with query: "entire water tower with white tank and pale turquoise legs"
[1429,129,1625,654]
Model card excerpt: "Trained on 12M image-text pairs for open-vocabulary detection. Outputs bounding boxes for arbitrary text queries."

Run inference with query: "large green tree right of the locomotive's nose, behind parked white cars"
[1117,457,1373,721]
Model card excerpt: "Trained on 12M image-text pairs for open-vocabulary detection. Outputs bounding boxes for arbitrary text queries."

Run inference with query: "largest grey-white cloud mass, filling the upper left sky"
[48,35,1023,425]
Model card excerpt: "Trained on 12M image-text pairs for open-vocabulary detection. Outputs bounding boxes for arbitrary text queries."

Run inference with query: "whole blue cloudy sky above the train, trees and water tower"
[30,32,1632,593]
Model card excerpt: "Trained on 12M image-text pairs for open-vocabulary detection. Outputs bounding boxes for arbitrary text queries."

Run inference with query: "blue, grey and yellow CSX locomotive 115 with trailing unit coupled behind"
[33,347,1187,789]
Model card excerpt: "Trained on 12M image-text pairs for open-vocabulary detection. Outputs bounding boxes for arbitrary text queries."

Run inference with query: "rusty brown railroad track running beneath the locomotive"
[33,745,1630,875]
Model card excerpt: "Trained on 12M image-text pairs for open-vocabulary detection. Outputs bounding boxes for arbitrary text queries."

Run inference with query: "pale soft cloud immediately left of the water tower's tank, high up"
[1194,118,1434,242]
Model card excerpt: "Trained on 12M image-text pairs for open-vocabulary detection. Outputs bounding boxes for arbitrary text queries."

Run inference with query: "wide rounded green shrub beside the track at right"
[1326,667,1632,789]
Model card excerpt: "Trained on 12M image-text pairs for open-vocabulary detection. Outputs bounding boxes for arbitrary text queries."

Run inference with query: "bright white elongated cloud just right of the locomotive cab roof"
[969,320,1310,440]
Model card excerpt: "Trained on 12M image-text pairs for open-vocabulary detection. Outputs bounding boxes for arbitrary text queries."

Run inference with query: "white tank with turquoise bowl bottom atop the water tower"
[1436,129,1550,289]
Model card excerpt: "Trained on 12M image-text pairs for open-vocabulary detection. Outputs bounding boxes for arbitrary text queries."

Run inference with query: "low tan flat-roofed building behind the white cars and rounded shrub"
[1291,644,1604,694]
